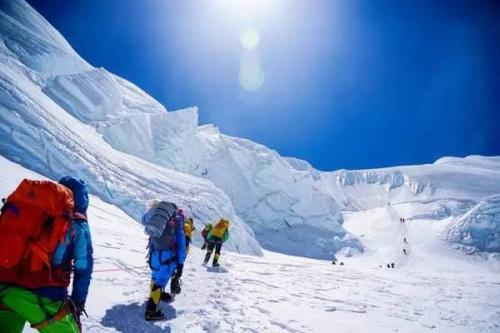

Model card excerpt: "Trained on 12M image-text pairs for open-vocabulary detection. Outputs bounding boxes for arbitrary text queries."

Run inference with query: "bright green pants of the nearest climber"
[0,284,80,333]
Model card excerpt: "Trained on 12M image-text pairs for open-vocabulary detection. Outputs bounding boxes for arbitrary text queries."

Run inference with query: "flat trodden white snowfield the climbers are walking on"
[0,159,500,333]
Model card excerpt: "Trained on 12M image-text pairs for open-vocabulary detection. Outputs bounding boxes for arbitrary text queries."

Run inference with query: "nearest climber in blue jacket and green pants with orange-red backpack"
[0,177,93,333]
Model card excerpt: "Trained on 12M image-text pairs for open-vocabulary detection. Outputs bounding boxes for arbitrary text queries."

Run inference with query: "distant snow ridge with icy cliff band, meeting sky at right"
[322,156,500,210]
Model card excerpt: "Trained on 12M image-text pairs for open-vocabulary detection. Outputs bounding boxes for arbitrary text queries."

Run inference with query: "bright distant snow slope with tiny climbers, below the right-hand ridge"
[337,204,500,272]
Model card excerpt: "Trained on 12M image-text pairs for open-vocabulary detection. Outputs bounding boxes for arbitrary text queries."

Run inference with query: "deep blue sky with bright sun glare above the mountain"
[28,0,500,170]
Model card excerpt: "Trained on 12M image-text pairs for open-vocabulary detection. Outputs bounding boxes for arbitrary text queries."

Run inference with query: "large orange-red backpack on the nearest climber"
[0,179,74,288]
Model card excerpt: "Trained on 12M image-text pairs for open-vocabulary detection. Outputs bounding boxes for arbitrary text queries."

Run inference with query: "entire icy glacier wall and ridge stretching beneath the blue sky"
[0,0,500,259]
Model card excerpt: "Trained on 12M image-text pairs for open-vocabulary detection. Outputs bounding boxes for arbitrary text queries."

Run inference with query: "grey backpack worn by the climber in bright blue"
[143,201,179,251]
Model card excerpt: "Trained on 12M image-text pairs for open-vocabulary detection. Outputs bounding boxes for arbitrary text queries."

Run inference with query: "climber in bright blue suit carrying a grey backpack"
[142,199,186,321]
